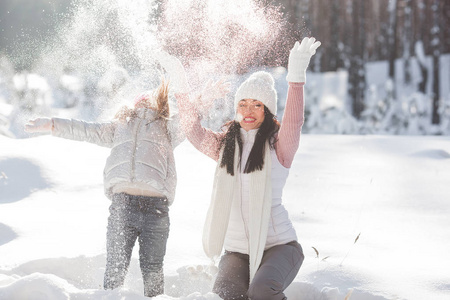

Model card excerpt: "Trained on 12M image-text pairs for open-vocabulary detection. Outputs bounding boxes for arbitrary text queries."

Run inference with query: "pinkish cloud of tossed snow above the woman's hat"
[159,0,285,82]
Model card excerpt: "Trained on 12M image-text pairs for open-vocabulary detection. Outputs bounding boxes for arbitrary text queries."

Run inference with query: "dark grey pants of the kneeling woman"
[213,241,304,300]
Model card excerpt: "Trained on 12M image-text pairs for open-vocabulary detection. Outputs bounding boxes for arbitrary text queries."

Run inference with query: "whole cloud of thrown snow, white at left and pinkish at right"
[35,0,289,118]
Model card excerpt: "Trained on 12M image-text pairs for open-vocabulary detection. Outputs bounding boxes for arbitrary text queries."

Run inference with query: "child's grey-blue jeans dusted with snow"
[104,193,170,297]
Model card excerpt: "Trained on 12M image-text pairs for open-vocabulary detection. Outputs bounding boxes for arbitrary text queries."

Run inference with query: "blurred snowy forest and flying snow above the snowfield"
[0,0,450,138]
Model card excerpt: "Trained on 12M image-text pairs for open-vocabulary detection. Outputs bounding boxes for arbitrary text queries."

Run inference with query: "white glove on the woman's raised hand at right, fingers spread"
[286,37,320,82]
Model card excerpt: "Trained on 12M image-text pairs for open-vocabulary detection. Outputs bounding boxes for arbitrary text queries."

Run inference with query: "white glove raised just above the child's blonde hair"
[154,51,190,94]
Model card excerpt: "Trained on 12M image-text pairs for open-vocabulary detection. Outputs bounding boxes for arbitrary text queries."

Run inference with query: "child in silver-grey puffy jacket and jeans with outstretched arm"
[25,80,184,297]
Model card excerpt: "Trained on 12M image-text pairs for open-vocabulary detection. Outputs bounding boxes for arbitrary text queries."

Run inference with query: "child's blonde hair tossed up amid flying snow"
[114,77,170,122]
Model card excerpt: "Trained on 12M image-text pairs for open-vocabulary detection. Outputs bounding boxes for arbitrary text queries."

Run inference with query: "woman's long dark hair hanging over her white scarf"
[220,106,280,176]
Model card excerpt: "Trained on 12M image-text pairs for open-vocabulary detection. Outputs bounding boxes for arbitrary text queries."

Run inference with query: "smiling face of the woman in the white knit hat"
[236,99,264,131]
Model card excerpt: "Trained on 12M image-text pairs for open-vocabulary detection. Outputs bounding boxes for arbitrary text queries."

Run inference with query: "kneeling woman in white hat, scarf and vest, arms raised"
[163,38,320,300]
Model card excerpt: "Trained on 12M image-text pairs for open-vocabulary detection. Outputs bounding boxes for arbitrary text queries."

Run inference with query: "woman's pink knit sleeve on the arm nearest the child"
[175,94,223,161]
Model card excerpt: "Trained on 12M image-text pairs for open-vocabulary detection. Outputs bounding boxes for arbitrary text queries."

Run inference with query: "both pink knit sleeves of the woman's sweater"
[176,82,304,168]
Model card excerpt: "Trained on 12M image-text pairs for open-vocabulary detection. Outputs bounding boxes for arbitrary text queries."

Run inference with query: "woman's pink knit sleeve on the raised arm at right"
[275,82,305,168]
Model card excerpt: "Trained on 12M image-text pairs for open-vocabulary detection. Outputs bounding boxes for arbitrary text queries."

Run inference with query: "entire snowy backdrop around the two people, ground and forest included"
[0,0,450,300]
